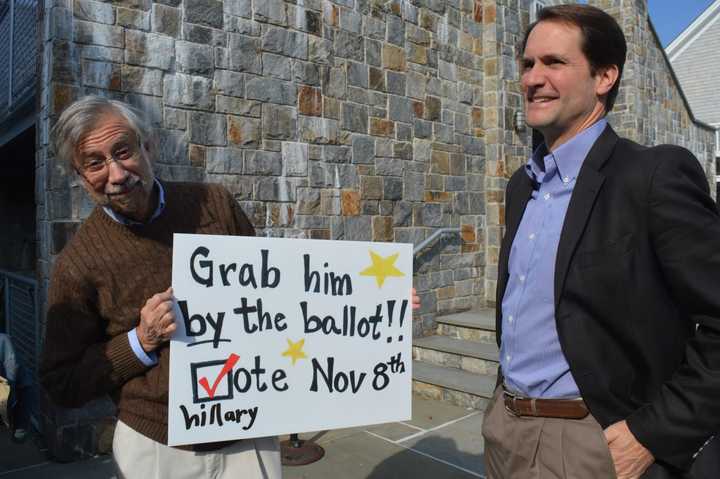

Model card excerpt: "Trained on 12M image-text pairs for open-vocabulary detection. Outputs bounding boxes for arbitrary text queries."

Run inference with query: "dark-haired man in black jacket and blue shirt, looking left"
[483,5,720,479]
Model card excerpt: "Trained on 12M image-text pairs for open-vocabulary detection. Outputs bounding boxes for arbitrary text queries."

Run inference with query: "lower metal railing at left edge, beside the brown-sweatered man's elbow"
[0,270,41,379]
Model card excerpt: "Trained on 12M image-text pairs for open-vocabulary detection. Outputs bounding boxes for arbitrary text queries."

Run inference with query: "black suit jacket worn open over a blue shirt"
[497,126,720,469]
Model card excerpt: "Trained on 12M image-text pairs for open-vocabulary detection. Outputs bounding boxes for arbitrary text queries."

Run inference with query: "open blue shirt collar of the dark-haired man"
[525,118,607,183]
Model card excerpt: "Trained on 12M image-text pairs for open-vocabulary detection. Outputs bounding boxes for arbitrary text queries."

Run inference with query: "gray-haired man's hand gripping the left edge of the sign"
[136,288,176,353]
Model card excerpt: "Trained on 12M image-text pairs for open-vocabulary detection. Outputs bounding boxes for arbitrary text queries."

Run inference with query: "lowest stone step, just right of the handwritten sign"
[413,361,496,409]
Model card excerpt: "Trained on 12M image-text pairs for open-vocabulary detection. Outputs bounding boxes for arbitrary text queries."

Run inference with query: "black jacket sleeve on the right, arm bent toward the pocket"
[627,146,720,469]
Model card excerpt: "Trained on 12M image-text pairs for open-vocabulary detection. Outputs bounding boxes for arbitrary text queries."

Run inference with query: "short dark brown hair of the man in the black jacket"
[520,5,627,112]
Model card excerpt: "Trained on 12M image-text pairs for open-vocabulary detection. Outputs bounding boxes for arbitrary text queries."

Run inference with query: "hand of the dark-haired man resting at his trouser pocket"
[605,421,655,479]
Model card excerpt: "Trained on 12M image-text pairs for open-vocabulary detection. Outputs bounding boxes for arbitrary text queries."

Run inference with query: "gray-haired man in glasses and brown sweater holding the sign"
[41,97,281,479]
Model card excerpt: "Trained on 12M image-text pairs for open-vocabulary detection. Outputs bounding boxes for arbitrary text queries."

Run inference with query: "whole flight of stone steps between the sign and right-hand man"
[413,309,499,409]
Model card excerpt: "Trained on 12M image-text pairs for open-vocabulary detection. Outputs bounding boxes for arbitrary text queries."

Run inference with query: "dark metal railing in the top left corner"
[0,0,38,118]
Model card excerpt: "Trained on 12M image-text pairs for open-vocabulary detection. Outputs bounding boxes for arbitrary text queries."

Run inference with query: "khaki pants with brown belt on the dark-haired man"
[482,387,616,479]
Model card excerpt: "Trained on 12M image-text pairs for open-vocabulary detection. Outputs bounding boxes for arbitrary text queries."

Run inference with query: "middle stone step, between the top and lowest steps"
[413,336,499,374]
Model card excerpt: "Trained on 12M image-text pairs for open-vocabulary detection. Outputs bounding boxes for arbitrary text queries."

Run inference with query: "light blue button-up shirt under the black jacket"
[500,119,607,398]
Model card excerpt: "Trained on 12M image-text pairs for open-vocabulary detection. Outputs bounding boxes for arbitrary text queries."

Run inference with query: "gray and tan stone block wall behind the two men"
[36,0,715,450]
